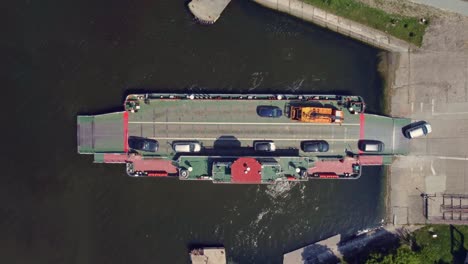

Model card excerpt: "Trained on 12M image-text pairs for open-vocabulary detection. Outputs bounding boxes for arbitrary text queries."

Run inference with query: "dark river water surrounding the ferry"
[4,0,385,264]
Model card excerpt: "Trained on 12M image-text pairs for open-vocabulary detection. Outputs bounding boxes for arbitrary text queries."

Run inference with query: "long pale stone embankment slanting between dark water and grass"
[253,0,412,52]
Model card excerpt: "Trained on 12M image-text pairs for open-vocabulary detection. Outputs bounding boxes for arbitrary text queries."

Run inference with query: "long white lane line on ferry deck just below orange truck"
[128,121,359,126]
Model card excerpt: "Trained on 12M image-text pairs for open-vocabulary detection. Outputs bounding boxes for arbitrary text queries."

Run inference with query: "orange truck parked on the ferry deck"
[290,106,343,123]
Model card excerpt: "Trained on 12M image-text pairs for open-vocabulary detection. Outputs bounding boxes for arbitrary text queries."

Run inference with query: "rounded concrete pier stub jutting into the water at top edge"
[188,0,231,24]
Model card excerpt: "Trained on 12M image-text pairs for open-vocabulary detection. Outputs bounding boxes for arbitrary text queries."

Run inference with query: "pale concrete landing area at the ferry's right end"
[389,15,468,225]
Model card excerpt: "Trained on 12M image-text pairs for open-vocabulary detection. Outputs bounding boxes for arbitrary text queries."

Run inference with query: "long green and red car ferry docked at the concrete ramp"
[78,94,410,183]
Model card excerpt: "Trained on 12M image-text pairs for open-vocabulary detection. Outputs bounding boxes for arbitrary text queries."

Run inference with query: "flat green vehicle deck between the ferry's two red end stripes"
[129,100,366,156]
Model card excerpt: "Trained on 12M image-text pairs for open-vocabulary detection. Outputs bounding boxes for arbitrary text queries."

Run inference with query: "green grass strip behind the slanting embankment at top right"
[304,0,427,47]
